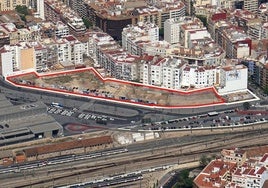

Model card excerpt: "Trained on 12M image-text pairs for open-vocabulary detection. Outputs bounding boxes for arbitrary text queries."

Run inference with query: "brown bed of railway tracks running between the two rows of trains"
[2,129,268,187]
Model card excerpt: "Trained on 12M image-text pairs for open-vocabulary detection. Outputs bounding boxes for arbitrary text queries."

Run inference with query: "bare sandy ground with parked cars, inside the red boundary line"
[11,71,221,106]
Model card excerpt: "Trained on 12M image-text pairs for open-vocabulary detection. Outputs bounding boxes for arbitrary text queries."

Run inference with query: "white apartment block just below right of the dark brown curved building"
[122,22,159,55]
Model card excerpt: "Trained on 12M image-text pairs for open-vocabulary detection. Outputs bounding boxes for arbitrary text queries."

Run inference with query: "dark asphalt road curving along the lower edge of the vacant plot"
[0,77,251,123]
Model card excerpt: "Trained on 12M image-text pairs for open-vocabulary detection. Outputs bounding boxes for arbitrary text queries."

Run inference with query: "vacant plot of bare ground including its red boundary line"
[9,69,224,106]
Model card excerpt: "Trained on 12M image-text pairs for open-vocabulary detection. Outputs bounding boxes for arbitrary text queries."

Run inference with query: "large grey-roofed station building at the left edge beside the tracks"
[0,95,63,146]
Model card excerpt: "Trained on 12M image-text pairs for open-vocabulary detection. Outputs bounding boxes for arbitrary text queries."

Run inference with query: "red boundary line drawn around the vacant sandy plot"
[6,67,225,109]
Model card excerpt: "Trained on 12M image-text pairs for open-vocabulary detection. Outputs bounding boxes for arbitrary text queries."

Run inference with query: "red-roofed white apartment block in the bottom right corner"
[194,148,268,188]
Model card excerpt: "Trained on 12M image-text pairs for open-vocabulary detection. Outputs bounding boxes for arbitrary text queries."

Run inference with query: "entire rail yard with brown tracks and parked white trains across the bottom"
[0,123,268,187]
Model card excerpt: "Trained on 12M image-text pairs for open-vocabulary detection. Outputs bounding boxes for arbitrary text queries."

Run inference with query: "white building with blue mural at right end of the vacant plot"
[218,64,248,94]
